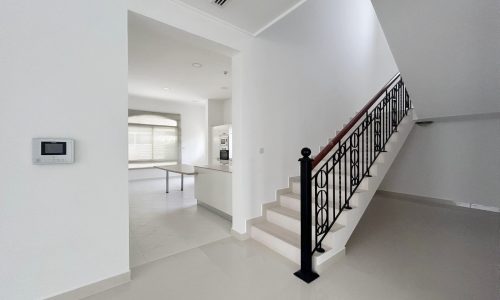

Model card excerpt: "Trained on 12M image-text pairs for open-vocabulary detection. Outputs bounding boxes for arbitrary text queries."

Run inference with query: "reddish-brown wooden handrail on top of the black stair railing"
[312,72,401,169]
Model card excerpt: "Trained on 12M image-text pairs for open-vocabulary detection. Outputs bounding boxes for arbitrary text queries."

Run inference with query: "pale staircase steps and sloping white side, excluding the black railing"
[249,74,414,270]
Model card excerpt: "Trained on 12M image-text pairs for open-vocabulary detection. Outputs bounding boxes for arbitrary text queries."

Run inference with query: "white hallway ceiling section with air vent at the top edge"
[175,0,305,35]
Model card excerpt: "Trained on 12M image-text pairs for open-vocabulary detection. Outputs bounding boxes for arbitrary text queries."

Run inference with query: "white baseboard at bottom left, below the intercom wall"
[46,271,130,300]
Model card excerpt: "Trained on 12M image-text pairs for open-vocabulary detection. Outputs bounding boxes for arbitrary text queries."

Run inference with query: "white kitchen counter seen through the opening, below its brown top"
[194,164,233,220]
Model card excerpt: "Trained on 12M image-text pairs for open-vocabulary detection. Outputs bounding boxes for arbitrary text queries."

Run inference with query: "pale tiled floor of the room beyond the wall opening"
[129,176,231,267]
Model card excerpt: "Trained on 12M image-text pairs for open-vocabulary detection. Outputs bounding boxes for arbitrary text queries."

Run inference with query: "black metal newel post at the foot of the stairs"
[294,148,319,283]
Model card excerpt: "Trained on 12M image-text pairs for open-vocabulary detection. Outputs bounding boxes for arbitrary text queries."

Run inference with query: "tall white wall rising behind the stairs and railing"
[232,0,397,233]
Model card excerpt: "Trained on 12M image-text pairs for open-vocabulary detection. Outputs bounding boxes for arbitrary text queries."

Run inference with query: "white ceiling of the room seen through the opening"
[128,12,233,102]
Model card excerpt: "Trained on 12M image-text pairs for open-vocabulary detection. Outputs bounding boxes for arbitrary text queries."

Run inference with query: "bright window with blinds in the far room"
[128,111,180,168]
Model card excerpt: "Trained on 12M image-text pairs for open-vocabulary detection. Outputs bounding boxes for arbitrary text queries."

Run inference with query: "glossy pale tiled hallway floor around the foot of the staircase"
[89,196,500,300]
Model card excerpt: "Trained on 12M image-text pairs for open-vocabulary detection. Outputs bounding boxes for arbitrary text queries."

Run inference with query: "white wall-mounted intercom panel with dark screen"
[32,138,75,165]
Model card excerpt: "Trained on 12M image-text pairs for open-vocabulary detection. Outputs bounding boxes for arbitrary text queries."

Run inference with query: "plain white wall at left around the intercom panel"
[0,0,129,299]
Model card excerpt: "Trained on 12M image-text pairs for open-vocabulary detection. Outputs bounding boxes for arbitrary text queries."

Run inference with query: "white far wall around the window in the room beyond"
[128,95,208,180]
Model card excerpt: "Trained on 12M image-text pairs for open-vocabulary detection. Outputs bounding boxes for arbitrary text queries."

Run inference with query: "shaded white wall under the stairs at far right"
[380,117,500,207]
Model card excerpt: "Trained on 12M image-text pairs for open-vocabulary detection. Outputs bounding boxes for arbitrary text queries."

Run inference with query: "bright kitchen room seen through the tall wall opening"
[128,12,232,267]
